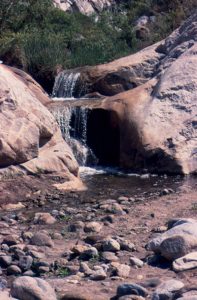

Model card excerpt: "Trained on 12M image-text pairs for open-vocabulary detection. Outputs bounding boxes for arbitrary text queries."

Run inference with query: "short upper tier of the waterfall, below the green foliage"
[52,71,81,99]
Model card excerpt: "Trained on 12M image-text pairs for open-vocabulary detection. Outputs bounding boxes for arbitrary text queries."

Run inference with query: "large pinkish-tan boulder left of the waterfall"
[0,65,78,177]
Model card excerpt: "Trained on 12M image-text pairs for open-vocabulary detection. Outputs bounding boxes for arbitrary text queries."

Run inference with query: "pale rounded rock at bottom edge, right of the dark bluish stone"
[152,279,184,300]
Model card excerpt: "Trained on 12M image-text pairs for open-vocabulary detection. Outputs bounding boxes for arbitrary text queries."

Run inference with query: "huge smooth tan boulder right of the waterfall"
[52,14,197,174]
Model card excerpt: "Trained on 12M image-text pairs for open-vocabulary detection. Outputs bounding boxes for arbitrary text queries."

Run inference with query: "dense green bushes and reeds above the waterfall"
[0,0,197,90]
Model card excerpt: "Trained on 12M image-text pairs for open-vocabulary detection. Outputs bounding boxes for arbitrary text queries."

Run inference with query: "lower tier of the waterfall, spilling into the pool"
[51,105,97,166]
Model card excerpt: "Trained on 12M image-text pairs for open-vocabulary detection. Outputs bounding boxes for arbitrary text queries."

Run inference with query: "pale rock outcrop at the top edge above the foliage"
[54,0,117,15]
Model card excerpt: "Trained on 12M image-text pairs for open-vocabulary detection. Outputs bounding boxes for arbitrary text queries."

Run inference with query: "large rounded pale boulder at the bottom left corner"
[10,276,57,300]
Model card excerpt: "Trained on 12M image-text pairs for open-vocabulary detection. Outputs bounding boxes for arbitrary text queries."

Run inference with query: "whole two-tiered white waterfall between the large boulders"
[52,71,97,166]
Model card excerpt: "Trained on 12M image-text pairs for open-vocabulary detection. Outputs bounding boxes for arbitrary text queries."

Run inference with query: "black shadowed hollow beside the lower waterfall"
[87,109,120,166]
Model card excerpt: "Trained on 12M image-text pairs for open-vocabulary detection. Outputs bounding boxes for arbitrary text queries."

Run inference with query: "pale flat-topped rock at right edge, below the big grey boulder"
[172,252,197,272]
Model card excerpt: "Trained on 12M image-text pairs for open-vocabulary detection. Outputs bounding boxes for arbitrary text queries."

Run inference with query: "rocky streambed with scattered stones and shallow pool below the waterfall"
[0,169,197,300]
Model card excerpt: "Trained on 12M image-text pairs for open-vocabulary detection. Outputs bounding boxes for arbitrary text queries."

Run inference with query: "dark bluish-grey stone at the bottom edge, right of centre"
[117,283,148,297]
